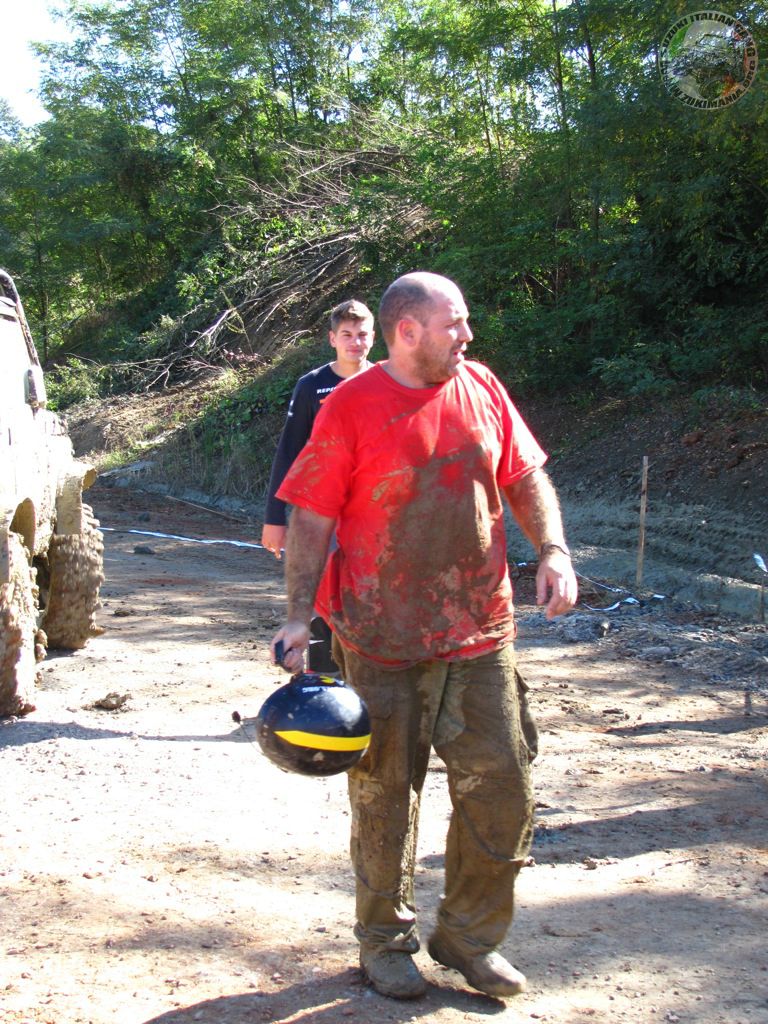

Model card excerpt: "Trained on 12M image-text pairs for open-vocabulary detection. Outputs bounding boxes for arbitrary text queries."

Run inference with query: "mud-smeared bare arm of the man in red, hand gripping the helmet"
[270,508,336,672]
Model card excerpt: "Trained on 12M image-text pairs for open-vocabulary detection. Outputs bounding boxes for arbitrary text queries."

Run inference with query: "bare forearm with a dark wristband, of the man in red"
[504,469,579,618]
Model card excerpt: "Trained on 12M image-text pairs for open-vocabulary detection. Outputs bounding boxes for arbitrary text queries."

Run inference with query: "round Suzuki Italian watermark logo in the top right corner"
[659,10,758,111]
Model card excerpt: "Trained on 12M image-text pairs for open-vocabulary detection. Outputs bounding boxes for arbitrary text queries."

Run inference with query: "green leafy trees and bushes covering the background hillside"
[0,0,768,456]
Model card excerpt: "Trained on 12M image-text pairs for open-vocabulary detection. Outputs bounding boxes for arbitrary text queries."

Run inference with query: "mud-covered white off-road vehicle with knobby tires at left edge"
[0,270,103,717]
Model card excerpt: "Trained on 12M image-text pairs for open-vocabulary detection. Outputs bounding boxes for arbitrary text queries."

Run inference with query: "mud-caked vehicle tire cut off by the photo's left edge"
[0,534,38,717]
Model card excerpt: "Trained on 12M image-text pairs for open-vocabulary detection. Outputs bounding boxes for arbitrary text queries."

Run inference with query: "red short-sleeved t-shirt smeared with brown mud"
[278,362,547,666]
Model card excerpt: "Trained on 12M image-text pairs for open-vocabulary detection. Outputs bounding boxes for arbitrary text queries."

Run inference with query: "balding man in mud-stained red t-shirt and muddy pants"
[272,273,577,998]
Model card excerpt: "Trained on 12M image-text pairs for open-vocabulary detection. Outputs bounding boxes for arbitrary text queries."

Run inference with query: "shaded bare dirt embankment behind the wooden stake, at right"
[523,393,768,623]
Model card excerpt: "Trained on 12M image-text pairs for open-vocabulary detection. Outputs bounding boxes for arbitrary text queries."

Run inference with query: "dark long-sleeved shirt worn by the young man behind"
[264,362,344,526]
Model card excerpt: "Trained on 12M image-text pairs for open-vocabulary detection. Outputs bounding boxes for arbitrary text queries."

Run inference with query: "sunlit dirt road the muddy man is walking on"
[0,487,768,1024]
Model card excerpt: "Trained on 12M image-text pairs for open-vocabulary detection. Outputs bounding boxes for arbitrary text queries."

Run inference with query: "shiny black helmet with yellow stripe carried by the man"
[256,672,371,775]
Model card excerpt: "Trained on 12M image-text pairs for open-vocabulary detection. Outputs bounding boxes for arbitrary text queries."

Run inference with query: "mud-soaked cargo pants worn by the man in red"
[334,636,537,955]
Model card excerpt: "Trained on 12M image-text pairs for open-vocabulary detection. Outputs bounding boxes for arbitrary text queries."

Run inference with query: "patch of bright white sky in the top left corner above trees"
[0,0,72,126]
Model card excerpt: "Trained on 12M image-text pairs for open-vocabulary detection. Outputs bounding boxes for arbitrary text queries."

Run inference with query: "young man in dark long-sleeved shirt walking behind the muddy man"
[261,299,374,558]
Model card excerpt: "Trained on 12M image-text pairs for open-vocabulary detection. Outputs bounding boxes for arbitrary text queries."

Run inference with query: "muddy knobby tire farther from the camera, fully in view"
[43,505,104,650]
